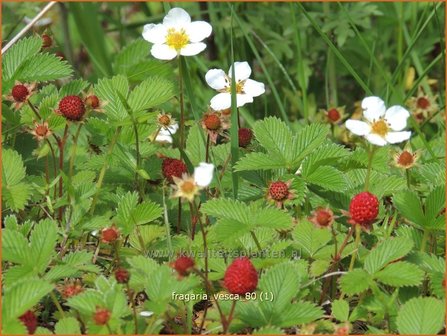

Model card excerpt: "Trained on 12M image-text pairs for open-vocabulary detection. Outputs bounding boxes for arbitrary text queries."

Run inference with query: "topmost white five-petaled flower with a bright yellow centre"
[143,8,212,60]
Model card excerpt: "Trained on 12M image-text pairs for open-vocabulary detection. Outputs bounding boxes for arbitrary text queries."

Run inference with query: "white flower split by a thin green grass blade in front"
[205,62,265,111]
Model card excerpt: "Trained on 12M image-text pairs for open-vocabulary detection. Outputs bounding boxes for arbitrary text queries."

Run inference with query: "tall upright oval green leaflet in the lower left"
[30,219,57,273]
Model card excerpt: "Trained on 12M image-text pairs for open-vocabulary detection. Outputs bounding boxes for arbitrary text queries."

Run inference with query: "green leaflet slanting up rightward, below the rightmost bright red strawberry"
[365,237,413,274]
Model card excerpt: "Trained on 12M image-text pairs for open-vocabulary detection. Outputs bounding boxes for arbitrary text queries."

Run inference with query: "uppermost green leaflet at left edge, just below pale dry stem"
[2,36,42,81]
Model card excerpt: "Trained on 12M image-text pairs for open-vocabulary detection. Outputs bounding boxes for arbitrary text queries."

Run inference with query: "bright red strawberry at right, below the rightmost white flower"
[349,191,379,226]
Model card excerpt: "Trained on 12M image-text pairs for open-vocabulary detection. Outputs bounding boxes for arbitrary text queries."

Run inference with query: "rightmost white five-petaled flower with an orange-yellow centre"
[346,97,411,146]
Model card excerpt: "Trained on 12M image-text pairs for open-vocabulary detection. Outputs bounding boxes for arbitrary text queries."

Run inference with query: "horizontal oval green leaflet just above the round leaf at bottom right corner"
[374,261,424,287]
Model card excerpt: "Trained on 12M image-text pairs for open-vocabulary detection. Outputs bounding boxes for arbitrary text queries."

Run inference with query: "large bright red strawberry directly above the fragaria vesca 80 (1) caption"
[224,257,258,295]
